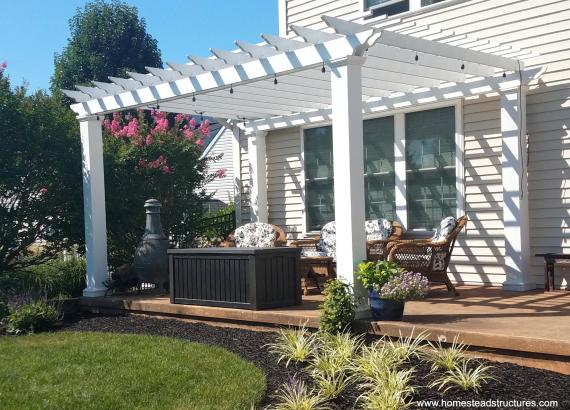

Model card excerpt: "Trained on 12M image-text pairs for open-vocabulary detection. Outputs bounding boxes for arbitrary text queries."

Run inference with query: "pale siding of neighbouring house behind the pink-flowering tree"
[205,129,235,203]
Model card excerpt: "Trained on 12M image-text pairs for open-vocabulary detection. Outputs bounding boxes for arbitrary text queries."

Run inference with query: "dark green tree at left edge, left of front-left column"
[0,64,83,271]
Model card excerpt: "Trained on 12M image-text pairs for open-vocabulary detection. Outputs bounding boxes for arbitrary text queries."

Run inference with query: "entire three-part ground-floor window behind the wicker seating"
[303,107,457,231]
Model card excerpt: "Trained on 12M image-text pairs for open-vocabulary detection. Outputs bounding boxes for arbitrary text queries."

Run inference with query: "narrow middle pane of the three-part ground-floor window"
[364,117,396,220]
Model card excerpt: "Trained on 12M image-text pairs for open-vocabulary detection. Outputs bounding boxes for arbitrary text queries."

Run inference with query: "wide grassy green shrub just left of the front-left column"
[0,259,86,298]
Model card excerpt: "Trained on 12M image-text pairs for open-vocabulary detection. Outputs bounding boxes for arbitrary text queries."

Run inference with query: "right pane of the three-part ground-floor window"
[406,107,457,229]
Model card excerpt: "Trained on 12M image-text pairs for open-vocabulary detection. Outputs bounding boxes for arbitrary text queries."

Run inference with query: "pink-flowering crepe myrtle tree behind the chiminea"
[103,110,225,266]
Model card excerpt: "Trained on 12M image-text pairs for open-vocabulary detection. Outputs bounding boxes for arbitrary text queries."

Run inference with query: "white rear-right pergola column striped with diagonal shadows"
[501,88,536,291]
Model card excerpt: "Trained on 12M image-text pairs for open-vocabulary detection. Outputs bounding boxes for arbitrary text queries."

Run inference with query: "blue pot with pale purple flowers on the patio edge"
[370,272,429,320]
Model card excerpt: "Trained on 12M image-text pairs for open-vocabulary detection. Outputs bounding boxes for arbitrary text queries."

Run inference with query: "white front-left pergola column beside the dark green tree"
[79,117,108,297]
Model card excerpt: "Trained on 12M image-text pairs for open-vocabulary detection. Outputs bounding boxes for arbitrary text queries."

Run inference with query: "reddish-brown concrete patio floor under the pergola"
[81,286,570,374]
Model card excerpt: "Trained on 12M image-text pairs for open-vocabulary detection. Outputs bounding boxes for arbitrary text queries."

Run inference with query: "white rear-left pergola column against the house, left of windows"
[247,131,268,222]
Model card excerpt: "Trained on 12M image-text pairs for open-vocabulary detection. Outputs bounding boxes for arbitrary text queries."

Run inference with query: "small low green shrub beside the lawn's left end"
[7,300,59,334]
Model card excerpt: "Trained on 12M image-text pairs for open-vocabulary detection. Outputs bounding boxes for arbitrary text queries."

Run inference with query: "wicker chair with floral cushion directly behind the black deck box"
[220,222,287,248]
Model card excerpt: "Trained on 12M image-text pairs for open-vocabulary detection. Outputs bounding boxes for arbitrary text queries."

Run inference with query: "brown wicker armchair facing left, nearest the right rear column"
[386,216,467,296]
